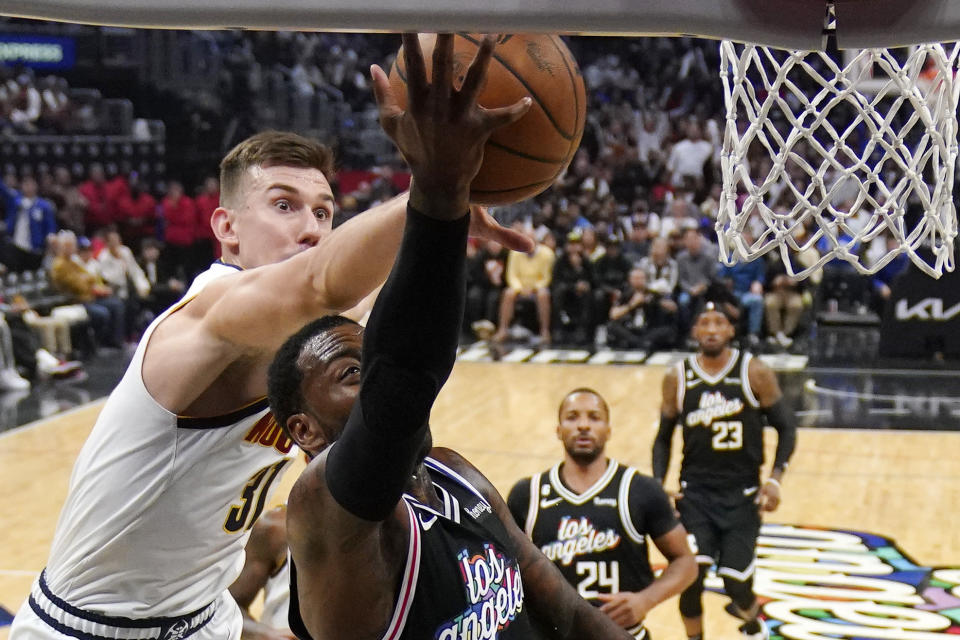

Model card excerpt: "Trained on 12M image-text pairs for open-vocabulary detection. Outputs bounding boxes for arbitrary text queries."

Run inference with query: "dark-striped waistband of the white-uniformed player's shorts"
[29,571,219,640]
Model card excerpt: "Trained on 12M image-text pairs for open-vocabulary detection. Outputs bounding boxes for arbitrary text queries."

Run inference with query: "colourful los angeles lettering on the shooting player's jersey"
[434,544,523,640]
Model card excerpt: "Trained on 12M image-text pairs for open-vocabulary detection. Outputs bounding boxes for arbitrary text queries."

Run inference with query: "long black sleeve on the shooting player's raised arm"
[325,206,470,521]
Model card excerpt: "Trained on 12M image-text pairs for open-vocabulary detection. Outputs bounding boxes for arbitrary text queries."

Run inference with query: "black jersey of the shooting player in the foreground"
[290,458,535,640]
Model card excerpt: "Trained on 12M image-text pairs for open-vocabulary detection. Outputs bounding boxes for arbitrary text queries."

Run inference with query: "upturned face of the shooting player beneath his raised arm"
[291,324,363,453]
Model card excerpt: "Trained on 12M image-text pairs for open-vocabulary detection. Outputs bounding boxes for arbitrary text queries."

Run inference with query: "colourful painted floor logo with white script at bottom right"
[707,524,960,640]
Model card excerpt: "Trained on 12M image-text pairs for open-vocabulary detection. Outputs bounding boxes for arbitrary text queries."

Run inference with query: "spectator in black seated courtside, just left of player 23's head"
[607,267,677,351]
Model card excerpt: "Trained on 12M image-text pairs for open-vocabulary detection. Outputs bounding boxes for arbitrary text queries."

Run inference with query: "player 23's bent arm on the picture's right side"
[748,359,797,511]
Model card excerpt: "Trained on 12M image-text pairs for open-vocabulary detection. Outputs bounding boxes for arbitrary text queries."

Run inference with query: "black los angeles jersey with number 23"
[677,349,764,490]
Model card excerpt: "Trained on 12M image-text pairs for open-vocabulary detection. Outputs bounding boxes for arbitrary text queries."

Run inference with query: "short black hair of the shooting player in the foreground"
[267,316,357,437]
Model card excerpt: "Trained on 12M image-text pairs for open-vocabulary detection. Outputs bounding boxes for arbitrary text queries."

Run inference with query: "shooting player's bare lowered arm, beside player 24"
[443,450,633,640]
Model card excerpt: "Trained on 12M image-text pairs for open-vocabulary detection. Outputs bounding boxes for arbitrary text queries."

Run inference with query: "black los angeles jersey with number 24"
[508,460,678,637]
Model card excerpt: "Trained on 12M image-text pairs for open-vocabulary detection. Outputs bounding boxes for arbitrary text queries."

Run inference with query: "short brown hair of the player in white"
[220,131,333,204]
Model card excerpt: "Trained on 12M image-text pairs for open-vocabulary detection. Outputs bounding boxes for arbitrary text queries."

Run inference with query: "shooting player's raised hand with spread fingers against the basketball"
[370,33,531,219]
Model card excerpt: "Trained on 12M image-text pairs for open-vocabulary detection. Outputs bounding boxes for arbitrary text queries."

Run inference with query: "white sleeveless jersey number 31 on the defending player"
[46,263,294,618]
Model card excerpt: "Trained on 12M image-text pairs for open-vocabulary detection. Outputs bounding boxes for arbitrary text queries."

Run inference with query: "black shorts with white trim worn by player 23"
[677,487,760,582]
